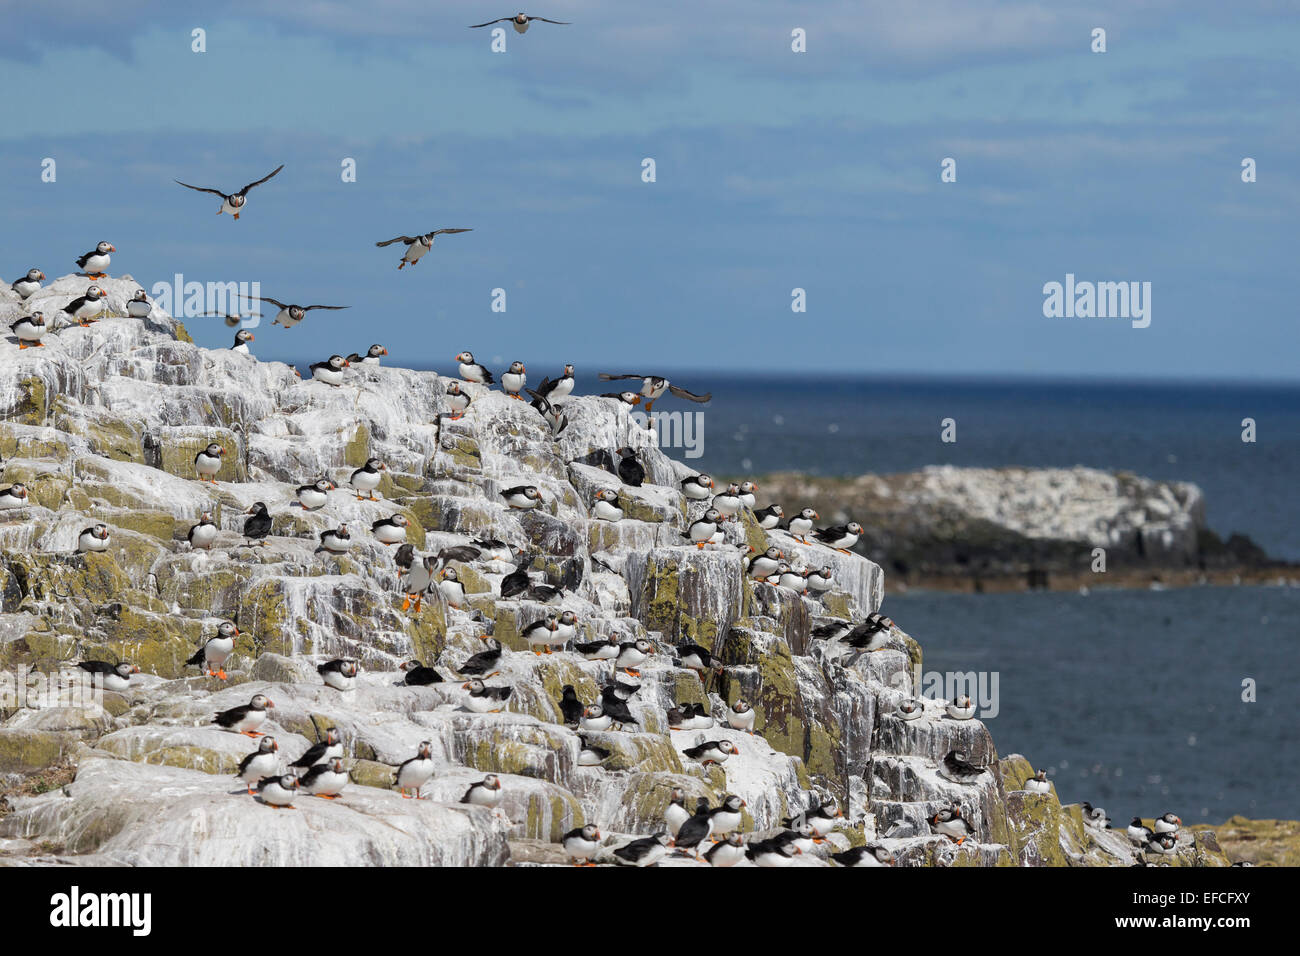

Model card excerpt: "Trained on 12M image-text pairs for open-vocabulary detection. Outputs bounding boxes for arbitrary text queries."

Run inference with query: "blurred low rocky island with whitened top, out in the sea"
[761,466,1300,592]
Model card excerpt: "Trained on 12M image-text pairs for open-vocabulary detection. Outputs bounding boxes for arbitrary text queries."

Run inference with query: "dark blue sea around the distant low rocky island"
[650,372,1300,826]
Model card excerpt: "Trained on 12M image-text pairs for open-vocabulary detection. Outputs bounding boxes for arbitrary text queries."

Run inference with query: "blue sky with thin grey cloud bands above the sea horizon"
[0,0,1300,381]
